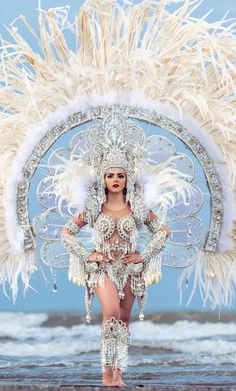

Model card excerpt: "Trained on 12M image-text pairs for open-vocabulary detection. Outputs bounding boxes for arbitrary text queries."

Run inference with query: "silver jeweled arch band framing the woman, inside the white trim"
[16,105,224,251]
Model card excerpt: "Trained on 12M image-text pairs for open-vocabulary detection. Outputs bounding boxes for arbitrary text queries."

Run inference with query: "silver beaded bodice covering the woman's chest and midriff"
[94,213,138,259]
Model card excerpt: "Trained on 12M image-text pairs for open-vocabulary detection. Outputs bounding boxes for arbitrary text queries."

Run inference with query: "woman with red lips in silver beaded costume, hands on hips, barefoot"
[62,167,169,387]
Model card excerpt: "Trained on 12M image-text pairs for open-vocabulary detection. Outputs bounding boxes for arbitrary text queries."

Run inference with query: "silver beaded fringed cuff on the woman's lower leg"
[101,317,130,371]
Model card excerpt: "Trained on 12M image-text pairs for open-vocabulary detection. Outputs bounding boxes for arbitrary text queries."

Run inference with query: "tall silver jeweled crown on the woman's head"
[86,111,146,182]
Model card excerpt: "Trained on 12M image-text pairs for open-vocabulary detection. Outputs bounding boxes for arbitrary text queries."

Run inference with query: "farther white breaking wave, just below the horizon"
[0,313,236,341]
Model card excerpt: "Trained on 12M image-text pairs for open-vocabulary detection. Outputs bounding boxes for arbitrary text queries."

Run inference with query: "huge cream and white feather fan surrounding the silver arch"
[0,0,236,306]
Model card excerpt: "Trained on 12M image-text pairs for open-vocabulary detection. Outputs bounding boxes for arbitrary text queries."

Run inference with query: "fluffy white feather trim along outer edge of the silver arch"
[5,92,235,251]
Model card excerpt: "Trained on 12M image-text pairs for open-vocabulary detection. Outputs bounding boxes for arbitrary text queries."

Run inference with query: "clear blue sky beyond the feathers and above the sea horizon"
[0,0,236,313]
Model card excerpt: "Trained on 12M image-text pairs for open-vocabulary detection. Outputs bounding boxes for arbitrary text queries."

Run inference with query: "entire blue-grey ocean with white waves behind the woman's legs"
[0,312,236,389]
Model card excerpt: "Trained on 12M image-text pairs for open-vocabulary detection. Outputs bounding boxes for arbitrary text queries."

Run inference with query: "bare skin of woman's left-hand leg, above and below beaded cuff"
[95,274,120,386]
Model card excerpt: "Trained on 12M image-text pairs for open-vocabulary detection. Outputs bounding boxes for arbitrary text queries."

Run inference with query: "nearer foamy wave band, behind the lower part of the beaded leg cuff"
[0,339,236,367]
